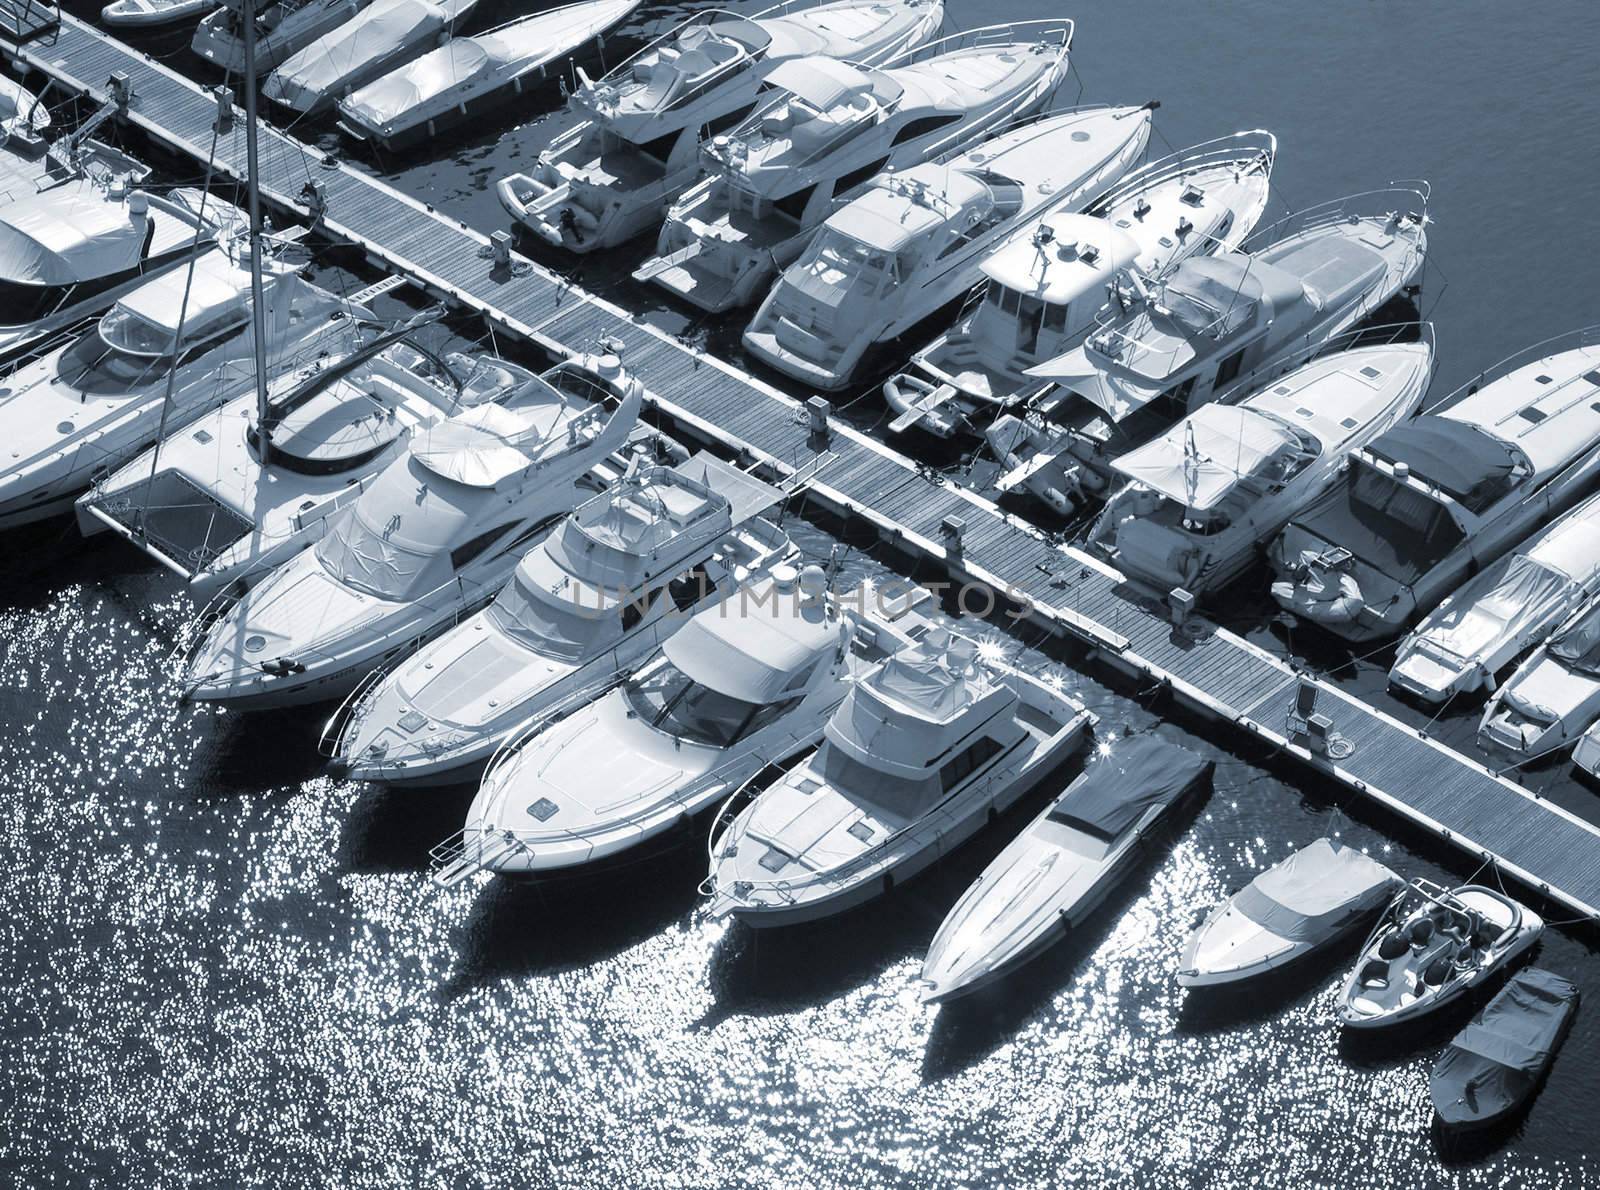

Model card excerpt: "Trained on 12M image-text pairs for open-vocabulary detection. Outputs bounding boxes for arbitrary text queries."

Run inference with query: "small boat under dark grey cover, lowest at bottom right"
[1427,968,1578,1128]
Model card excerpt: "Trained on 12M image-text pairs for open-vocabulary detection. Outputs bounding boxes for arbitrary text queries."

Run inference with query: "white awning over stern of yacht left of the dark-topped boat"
[1112,405,1304,512]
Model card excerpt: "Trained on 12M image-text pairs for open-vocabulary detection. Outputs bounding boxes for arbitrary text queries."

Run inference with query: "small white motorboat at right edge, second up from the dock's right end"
[1478,598,1600,765]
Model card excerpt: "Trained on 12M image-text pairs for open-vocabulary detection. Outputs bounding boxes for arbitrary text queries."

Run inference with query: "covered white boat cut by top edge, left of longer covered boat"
[261,0,478,115]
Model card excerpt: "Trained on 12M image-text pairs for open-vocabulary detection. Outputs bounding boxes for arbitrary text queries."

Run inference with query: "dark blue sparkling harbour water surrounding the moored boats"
[9,0,1600,1187]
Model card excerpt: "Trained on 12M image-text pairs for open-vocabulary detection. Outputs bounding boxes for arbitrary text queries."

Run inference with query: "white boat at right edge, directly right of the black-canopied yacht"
[1389,496,1600,704]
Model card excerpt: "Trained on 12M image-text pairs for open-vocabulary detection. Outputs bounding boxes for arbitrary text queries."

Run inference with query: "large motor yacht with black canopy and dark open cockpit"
[1269,329,1600,643]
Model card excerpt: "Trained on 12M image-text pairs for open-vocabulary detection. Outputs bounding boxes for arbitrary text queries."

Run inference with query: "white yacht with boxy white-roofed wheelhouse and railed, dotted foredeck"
[883,131,1277,441]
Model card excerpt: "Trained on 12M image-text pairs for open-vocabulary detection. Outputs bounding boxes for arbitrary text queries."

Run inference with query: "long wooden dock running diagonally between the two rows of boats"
[6,14,1600,918]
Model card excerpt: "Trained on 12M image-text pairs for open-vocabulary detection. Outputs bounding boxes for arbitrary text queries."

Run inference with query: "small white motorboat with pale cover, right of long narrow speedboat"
[1178,838,1400,987]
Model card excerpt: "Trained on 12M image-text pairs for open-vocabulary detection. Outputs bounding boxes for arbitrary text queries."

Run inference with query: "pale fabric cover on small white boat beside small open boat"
[1234,838,1397,942]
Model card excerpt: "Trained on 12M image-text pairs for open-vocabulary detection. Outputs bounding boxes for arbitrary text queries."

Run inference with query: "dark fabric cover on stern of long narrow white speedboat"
[1050,734,1211,840]
